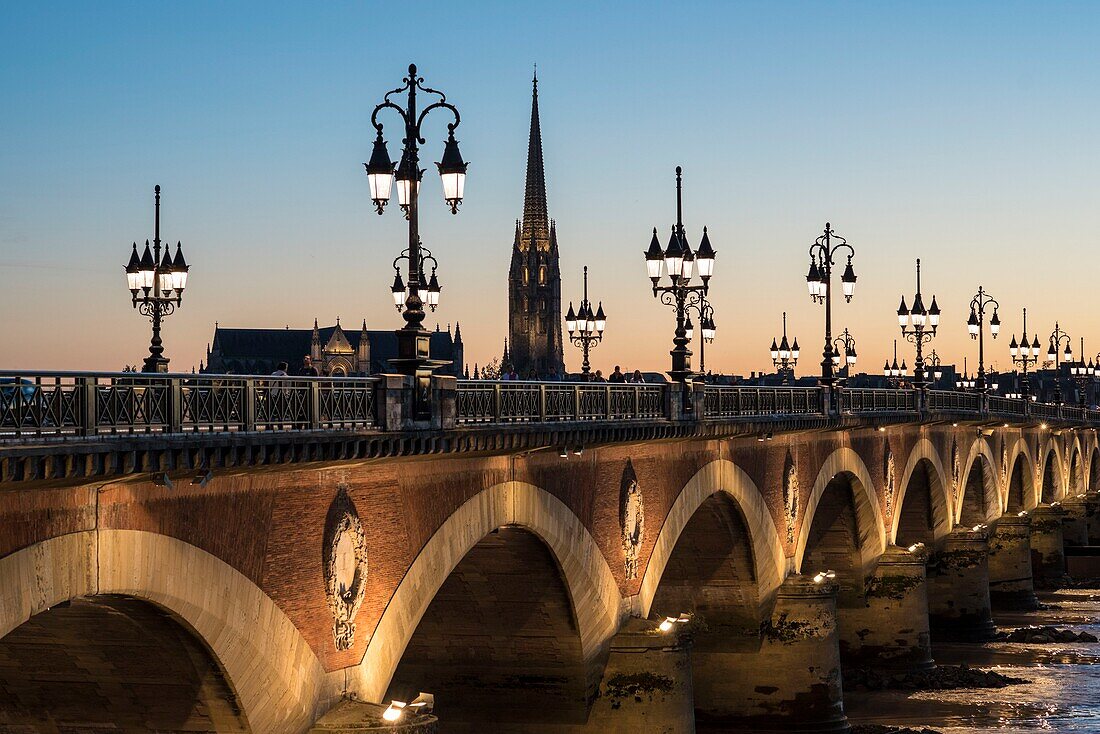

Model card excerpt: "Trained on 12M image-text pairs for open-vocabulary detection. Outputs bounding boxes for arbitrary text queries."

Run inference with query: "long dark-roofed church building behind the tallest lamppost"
[199,319,463,376]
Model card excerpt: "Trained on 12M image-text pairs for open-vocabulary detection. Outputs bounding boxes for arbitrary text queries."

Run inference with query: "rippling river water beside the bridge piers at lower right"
[844,589,1100,734]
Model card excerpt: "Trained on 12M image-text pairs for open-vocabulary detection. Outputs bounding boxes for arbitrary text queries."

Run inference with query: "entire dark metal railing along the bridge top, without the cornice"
[0,372,1100,439]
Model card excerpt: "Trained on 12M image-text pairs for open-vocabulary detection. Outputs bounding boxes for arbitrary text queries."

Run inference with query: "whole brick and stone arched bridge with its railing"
[0,374,1100,734]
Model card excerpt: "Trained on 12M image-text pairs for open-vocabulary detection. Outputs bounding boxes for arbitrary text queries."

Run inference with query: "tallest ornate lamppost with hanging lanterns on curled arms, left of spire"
[365,64,468,419]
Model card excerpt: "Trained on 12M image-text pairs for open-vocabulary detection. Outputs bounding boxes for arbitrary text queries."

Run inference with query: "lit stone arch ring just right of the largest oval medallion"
[348,481,623,702]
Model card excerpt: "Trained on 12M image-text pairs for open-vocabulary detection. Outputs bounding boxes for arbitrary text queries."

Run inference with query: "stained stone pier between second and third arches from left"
[584,618,695,734]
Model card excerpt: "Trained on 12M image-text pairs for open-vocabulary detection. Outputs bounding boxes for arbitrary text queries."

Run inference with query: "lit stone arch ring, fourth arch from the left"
[794,447,887,573]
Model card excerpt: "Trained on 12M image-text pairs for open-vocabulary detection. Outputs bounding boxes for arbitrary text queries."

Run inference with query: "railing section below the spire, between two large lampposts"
[457,380,668,425]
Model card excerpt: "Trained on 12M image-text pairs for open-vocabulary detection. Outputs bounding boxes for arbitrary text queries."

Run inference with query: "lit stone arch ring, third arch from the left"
[637,459,787,617]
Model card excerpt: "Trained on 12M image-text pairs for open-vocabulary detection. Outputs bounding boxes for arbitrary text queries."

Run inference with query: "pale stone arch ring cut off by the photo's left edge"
[0,529,325,732]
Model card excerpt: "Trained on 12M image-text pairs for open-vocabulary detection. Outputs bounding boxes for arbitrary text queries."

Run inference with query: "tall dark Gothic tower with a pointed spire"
[508,77,565,379]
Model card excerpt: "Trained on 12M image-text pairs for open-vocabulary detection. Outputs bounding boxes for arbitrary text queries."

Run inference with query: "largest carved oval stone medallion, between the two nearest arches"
[322,486,366,650]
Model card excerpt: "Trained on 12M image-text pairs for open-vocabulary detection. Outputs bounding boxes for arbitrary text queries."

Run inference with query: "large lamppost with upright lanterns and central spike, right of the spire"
[646,166,715,386]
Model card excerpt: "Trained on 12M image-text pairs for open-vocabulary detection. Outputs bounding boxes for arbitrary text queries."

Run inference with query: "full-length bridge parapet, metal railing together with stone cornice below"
[0,372,1100,482]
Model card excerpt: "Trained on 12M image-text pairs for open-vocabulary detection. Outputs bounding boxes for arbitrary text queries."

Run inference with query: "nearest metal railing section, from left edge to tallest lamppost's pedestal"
[0,372,377,437]
